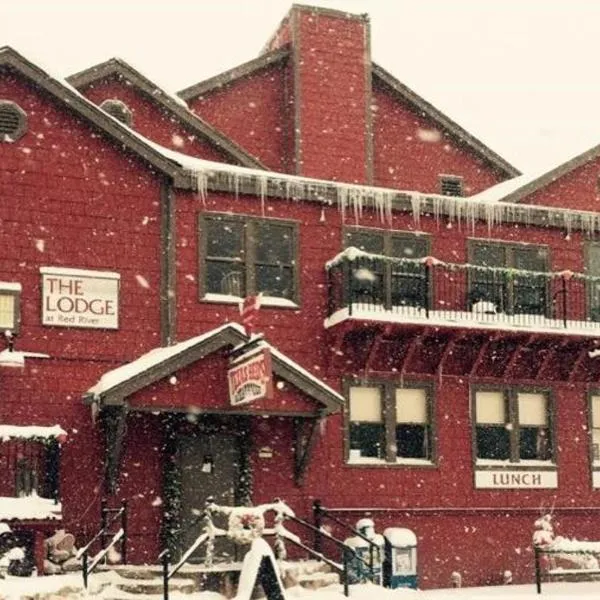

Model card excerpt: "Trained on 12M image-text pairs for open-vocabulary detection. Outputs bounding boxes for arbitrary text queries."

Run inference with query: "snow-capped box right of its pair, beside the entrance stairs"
[383,527,417,589]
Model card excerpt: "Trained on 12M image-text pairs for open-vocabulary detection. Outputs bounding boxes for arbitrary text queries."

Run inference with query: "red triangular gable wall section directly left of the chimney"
[188,62,293,173]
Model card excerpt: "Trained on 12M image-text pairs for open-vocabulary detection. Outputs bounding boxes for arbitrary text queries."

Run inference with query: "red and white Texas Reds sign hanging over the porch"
[227,348,273,406]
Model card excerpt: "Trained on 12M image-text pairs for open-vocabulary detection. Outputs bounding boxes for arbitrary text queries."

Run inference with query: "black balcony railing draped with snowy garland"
[326,248,600,335]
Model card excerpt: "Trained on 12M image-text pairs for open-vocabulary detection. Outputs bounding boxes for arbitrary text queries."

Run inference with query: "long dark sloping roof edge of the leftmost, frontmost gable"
[0,46,192,188]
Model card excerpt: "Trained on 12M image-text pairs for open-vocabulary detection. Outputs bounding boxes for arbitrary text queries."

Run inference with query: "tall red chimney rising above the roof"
[267,4,373,183]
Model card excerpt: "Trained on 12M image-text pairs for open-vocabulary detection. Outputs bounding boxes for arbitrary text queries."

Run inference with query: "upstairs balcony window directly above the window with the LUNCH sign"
[469,241,548,315]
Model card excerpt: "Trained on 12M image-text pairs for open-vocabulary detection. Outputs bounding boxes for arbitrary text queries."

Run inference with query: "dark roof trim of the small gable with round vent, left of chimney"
[67,58,266,169]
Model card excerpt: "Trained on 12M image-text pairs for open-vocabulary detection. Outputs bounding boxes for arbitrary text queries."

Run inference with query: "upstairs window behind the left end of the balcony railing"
[345,228,429,307]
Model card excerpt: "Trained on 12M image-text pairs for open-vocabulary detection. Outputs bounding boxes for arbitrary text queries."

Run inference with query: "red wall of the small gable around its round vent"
[80,77,237,164]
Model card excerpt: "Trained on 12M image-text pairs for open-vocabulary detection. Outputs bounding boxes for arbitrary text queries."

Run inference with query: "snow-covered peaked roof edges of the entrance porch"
[84,323,344,414]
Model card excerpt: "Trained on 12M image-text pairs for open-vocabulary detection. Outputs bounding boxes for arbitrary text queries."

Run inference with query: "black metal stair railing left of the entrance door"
[76,500,127,588]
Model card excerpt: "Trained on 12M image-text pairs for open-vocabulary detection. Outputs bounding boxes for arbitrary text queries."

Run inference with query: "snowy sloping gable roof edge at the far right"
[473,144,600,203]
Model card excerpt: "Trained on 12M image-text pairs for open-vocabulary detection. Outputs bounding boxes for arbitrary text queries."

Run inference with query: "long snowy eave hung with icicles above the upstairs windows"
[147,141,600,235]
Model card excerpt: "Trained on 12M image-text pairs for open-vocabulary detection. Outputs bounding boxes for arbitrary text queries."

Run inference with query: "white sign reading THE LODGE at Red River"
[40,267,120,329]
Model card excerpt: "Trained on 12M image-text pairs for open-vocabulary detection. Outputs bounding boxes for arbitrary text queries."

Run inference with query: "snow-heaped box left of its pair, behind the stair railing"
[344,519,385,585]
